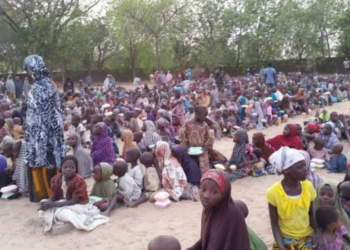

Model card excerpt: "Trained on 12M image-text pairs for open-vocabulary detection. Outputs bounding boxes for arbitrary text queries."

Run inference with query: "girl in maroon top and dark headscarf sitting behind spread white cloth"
[39,156,89,211]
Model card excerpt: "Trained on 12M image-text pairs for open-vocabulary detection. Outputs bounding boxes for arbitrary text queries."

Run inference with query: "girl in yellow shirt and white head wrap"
[266,147,322,250]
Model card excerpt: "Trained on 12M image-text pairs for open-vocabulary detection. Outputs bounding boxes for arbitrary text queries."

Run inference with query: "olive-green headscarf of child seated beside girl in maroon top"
[90,162,117,201]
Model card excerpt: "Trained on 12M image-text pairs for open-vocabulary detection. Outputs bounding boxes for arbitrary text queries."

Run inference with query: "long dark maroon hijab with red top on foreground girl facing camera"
[189,170,250,250]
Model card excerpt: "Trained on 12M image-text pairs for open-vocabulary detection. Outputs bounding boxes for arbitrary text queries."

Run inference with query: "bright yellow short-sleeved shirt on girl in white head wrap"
[266,181,316,240]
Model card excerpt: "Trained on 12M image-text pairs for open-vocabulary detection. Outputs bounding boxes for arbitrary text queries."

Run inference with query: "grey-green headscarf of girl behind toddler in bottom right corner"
[313,182,350,245]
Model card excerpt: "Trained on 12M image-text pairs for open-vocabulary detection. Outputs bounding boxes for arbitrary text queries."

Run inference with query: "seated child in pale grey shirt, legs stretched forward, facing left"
[102,160,141,216]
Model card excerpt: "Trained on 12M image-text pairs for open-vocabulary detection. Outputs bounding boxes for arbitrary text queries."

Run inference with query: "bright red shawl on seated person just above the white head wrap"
[267,124,303,150]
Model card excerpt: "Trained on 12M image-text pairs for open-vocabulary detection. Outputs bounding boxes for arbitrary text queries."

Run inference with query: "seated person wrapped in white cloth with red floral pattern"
[155,141,196,201]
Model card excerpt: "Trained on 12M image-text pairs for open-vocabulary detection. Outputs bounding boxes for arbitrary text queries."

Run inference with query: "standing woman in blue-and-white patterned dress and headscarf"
[23,55,65,202]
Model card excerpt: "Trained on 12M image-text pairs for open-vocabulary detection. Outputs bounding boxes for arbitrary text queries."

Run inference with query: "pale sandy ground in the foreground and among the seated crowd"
[0,103,350,250]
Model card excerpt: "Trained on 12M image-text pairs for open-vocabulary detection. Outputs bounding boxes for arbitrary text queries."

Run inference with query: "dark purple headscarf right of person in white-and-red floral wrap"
[171,145,201,185]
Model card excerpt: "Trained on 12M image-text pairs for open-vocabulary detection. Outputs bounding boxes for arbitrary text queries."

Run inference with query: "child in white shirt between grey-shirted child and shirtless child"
[125,148,144,189]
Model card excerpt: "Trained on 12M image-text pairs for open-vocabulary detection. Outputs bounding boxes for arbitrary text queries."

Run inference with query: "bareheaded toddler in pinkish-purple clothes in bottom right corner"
[313,206,348,250]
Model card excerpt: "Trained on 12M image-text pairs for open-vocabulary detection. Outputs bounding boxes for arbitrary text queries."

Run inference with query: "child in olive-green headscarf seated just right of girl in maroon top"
[90,162,117,212]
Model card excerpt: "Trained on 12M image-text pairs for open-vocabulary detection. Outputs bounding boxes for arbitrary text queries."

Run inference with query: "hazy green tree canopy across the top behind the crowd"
[0,0,350,77]
